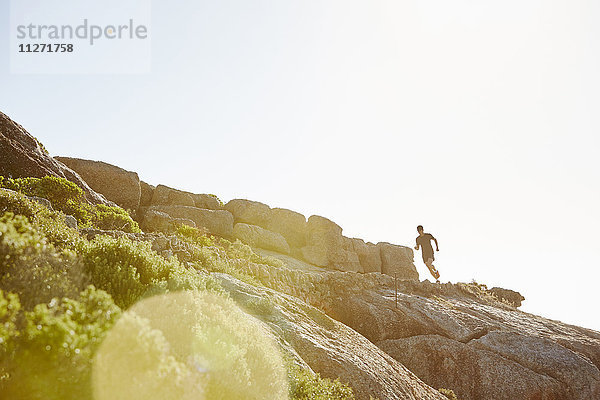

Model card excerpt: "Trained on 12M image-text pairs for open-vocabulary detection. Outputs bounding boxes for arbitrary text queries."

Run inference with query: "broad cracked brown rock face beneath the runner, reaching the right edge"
[297,273,600,400]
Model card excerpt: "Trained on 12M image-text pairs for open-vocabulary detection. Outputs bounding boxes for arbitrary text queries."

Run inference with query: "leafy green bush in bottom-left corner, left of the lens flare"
[0,286,121,400]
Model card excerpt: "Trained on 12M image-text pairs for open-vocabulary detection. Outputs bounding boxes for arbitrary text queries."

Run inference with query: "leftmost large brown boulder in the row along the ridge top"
[56,157,141,211]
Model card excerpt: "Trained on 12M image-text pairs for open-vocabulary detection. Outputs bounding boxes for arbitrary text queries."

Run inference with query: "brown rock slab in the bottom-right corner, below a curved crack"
[471,331,600,400]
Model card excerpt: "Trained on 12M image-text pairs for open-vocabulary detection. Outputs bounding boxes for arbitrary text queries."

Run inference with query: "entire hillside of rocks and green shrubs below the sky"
[0,113,600,400]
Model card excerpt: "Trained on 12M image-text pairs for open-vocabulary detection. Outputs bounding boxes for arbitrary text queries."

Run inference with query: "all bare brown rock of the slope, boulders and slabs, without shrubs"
[0,110,600,400]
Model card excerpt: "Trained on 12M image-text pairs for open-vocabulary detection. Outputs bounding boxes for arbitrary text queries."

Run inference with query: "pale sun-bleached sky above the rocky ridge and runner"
[0,0,600,330]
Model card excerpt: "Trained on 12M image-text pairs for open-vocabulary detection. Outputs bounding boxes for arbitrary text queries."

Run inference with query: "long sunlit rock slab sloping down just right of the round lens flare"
[213,274,447,400]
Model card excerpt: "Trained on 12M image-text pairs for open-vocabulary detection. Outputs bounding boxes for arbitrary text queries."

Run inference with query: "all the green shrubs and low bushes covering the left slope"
[0,183,354,400]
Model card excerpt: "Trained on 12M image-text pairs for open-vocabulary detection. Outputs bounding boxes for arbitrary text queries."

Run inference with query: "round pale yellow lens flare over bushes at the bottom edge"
[92,292,288,400]
